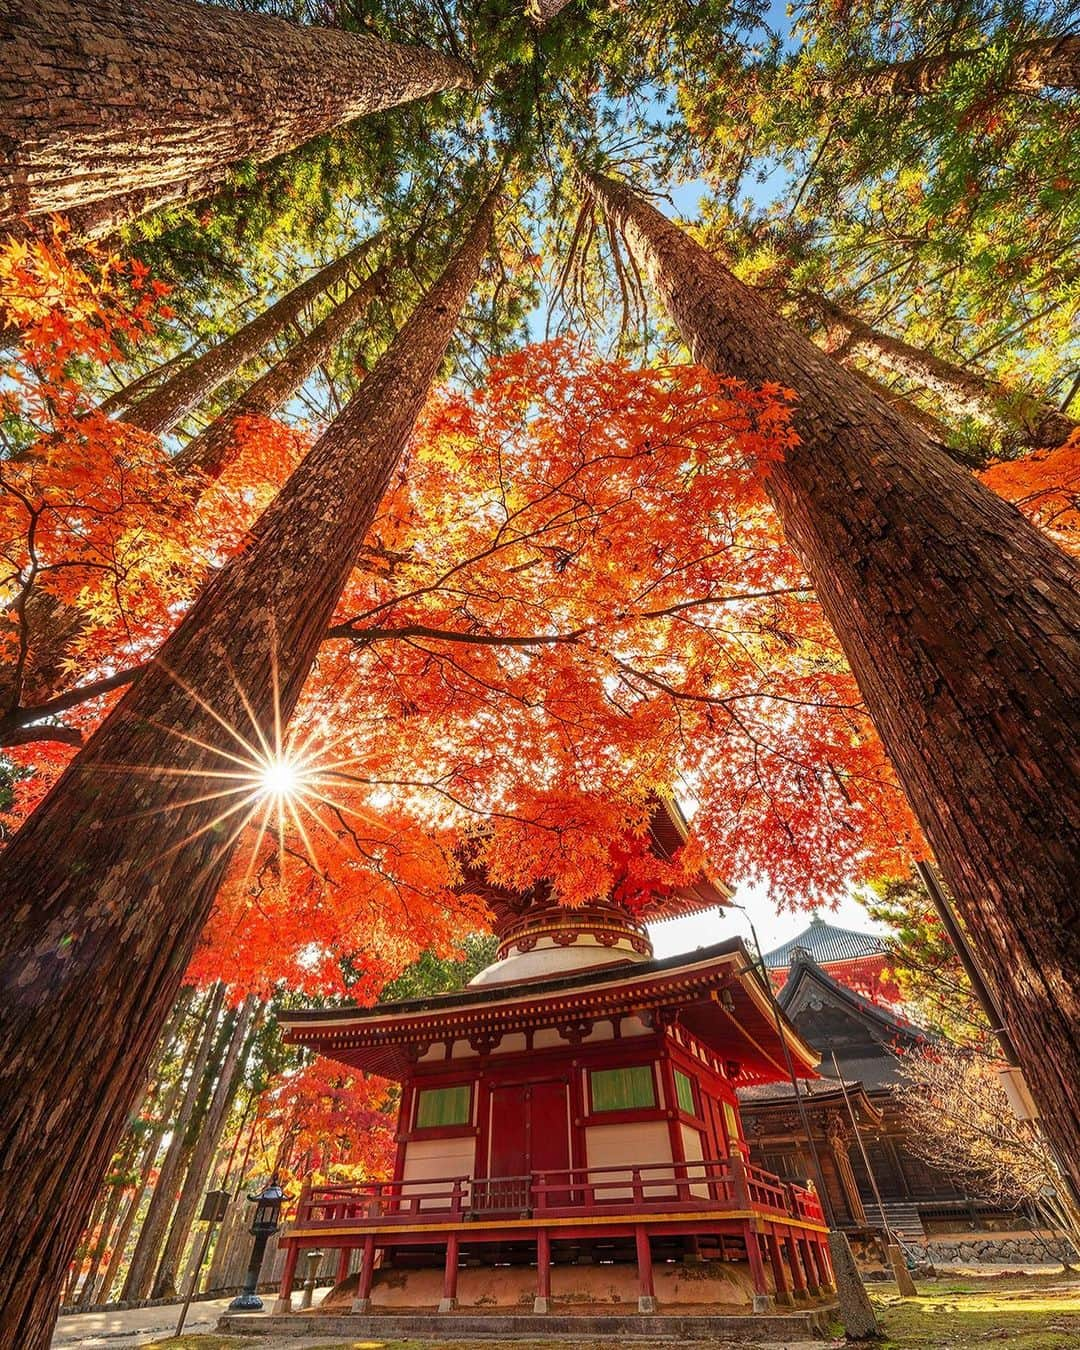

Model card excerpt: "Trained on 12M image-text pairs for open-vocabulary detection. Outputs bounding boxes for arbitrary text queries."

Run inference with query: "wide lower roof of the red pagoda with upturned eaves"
[279,938,819,1083]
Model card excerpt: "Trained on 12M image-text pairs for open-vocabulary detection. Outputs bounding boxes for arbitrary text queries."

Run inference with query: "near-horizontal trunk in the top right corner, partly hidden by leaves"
[811,38,1080,99]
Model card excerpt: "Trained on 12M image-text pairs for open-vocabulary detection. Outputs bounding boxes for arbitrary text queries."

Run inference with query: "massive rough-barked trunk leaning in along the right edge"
[587,168,1080,1193]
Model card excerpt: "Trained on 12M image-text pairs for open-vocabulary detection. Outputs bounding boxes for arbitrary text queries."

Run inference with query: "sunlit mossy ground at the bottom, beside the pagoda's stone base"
[147,1274,1080,1350]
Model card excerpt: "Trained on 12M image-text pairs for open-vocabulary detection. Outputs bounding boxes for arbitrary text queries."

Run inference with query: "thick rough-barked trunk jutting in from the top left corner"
[0,0,474,234]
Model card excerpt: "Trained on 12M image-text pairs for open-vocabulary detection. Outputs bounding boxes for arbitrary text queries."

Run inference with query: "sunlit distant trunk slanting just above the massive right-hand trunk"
[809,296,1080,450]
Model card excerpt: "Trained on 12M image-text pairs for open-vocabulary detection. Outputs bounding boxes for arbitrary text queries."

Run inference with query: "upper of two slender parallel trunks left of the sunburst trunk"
[122,234,382,436]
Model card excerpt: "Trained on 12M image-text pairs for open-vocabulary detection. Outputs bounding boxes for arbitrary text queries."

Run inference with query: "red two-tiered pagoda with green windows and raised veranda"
[275,803,832,1314]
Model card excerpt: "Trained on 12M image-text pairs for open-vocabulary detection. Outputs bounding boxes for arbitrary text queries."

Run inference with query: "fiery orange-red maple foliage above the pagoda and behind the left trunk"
[14,229,1069,999]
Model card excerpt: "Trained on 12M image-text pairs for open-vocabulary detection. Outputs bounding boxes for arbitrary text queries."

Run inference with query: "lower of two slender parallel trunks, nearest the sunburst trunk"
[173,255,389,478]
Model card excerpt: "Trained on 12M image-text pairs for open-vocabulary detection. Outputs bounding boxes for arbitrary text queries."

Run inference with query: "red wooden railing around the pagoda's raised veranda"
[296,1157,824,1229]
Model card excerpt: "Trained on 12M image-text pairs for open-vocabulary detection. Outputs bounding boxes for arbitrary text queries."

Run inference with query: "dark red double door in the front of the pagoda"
[479,1079,570,1210]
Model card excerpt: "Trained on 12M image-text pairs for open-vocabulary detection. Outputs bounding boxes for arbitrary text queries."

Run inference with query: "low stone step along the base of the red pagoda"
[217,1304,836,1345]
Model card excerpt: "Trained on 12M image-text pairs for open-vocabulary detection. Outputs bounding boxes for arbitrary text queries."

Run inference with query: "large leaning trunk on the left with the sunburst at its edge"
[0,182,495,1350]
